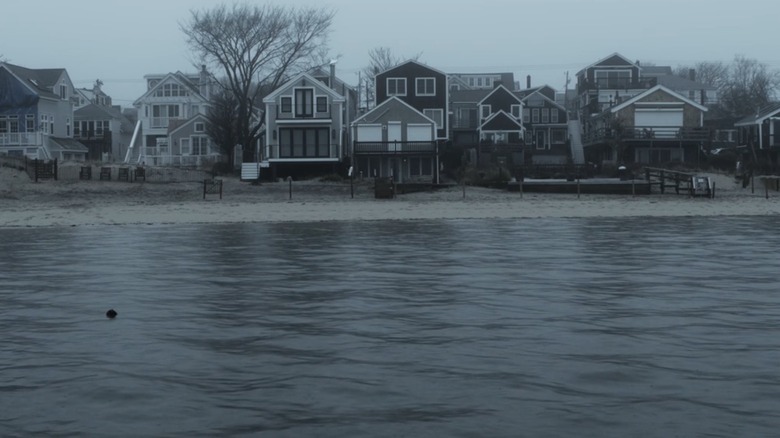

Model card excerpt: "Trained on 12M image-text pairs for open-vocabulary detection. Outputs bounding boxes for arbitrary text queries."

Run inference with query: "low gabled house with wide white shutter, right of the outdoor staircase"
[583,85,710,165]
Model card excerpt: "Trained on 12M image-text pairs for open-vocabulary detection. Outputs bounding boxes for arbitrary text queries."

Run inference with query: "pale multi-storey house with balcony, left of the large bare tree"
[130,66,222,166]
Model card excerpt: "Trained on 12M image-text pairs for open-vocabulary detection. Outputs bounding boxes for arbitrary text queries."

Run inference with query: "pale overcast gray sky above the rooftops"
[0,0,780,106]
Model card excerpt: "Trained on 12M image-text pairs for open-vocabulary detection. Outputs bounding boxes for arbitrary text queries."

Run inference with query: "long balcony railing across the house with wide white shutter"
[582,126,711,145]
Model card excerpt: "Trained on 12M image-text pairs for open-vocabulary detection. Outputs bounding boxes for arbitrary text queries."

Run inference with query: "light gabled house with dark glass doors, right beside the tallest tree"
[260,72,348,179]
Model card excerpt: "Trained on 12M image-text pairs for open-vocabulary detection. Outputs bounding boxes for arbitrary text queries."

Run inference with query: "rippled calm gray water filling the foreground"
[0,217,780,437]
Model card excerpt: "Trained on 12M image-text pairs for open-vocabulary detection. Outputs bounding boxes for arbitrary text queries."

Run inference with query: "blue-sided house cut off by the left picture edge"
[0,62,87,161]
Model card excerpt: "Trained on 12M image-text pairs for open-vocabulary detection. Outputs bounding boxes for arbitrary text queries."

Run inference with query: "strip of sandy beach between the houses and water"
[0,168,780,228]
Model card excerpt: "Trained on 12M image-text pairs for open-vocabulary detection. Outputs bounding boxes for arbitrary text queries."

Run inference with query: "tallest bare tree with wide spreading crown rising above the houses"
[180,4,334,161]
